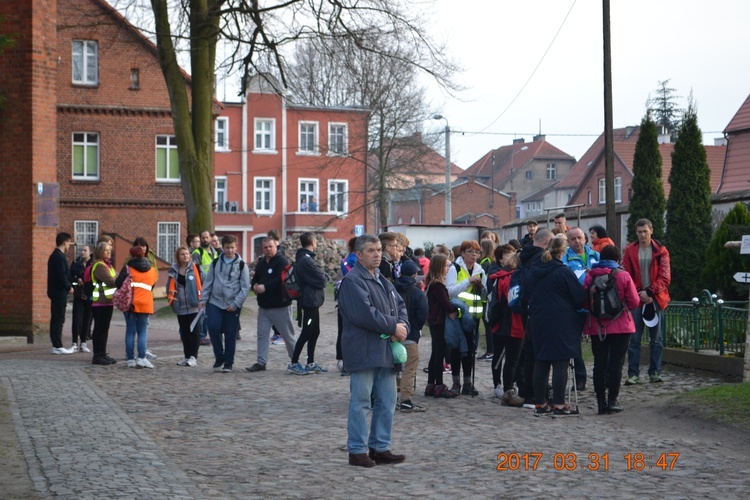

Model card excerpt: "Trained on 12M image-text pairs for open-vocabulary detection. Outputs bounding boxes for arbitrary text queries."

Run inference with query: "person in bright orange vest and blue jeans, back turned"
[115,246,158,368]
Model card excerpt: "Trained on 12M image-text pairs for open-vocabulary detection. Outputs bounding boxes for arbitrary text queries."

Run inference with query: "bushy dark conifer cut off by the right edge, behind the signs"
[701,203,750,300]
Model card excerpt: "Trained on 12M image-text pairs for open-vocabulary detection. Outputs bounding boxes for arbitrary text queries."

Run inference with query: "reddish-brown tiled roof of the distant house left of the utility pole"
[464,139,575,186]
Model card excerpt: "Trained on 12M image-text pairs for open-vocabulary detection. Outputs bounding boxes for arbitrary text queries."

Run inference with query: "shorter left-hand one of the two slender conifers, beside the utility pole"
[628,112,667,242]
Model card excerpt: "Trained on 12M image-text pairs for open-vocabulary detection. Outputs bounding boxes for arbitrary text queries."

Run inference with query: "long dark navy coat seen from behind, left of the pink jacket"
[521,259,587,361]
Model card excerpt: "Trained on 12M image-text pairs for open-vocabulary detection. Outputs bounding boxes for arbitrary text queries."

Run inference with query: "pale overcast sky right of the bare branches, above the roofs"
[425,0,750,168]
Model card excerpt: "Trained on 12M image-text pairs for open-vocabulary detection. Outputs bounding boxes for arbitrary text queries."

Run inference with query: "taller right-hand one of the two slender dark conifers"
[666,100,712,300]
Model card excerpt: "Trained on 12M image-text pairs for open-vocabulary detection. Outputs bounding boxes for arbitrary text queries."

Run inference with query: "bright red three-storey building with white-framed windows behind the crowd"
[214,75,374,260]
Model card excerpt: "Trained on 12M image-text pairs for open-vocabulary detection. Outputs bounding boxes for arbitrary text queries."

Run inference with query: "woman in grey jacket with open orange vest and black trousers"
[167,247,203,366]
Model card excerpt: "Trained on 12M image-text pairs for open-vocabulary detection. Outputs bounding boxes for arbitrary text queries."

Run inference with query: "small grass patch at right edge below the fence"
[677,382,750,429]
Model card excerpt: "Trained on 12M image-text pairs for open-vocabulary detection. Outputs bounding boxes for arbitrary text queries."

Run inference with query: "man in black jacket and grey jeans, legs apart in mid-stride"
[245,237,295,372]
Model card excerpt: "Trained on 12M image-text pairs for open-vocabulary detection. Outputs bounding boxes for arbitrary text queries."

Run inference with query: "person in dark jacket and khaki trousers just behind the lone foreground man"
[396,260,427,412]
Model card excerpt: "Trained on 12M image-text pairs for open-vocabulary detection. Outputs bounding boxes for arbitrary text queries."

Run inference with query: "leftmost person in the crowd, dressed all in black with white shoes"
[47,233,73,354]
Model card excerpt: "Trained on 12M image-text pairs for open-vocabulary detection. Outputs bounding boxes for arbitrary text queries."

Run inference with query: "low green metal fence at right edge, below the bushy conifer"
[668,290,748,356]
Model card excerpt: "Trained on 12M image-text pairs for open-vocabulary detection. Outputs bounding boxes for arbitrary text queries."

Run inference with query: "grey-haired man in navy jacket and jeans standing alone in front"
[339,234,409,467]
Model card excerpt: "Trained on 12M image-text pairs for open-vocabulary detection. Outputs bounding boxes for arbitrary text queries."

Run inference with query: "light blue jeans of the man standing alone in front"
[346,368,396,454]
